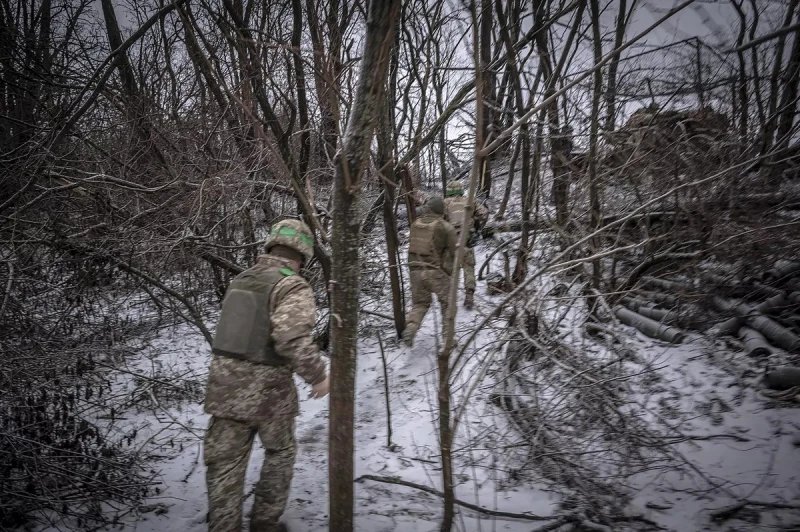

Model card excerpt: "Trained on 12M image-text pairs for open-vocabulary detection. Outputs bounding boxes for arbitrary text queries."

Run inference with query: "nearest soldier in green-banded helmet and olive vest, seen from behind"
[203,220,328,532]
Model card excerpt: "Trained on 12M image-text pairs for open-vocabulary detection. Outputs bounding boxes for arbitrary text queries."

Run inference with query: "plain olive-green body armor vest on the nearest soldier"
[211,268,294,366]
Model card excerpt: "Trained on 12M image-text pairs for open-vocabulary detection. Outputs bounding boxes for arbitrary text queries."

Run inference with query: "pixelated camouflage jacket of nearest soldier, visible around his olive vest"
[205,255,326,422]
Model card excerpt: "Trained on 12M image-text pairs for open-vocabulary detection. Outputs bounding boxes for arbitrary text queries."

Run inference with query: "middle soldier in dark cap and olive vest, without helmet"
[403,196,456,347]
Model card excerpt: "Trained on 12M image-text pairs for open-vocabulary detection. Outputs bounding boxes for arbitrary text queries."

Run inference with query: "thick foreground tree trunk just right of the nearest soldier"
[328,0,400,532]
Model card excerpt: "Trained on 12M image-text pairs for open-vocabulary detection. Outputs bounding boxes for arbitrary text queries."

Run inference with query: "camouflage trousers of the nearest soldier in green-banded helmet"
[203,416,297,532]
